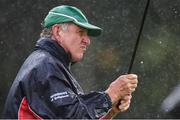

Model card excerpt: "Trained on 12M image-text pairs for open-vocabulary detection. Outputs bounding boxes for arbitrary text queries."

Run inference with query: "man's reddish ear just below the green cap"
[52,24,61,41]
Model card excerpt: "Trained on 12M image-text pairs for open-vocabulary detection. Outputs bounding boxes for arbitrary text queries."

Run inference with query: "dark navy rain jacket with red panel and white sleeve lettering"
[4,38,111,119]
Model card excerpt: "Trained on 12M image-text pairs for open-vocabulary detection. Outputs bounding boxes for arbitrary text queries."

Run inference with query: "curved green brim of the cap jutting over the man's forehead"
[73,21,102,37]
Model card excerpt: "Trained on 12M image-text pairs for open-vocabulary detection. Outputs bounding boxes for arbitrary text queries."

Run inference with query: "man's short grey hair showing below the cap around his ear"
[40,23,69,38]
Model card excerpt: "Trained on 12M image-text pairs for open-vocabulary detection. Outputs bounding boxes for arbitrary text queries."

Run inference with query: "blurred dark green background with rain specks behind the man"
[0,0,180,118]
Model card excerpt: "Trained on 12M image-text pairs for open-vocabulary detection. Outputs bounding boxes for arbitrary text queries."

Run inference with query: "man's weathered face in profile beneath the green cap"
[60,24,90,62]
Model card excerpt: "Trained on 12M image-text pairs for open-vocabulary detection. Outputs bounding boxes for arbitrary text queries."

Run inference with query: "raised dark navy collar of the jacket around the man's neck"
[34,38,71,68]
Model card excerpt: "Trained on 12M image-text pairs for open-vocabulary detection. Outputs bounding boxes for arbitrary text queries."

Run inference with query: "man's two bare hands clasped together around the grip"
[104,74,138,119]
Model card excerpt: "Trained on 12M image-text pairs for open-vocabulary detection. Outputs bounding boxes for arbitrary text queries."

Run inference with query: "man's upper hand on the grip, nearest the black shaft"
[105,74,138,107]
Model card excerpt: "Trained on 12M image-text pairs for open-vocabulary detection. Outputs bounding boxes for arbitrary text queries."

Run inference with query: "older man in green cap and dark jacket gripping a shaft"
[4,5,137,119]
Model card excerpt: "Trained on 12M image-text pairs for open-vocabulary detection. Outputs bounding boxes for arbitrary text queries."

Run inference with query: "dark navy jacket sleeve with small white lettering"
[25,60,111,119]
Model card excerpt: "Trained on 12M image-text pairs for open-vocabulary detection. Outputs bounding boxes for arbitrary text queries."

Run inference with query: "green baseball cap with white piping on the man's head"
[43,5,102,36]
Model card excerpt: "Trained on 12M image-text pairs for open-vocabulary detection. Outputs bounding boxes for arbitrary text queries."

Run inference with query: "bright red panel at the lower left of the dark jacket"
[18,97,42,120]
